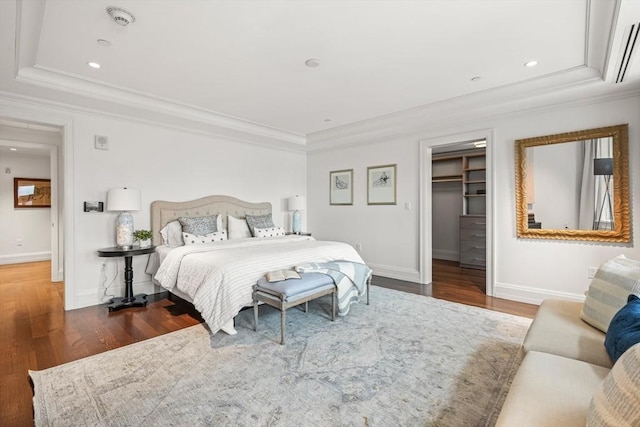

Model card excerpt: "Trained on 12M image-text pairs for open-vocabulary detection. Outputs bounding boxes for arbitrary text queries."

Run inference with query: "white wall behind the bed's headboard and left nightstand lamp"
[0,99,306,309]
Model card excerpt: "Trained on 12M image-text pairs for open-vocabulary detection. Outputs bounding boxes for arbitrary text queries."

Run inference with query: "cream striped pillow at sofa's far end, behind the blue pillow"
[580,255,640,333]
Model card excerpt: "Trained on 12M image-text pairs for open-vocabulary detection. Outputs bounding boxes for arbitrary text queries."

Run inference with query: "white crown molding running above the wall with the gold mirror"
[306,67,640,152]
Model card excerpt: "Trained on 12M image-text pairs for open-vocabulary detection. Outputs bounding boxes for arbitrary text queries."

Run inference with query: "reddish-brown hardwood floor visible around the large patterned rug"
[0,260,537,427]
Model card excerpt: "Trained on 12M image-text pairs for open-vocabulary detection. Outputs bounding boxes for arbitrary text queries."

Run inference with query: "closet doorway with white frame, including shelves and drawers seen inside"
[419,129,495,296]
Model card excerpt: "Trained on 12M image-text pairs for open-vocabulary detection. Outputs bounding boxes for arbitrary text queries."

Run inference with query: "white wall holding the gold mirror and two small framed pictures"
[307,96,640,303]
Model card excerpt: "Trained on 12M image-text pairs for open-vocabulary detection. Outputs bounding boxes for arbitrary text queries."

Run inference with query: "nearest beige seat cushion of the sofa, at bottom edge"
[496,351,609,427]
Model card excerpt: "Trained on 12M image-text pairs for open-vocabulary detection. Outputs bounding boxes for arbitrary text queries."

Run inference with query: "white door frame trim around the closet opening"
[419,129,495,296]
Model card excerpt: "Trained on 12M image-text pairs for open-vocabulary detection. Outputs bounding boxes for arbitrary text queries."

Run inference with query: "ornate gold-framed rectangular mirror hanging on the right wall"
[515,124,631,242]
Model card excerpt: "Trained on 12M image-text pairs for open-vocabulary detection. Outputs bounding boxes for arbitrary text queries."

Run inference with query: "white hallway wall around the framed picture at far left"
[0,154,51,264]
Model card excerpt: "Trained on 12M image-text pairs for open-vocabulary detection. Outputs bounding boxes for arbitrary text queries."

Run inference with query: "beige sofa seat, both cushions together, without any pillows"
[496,300,612,427]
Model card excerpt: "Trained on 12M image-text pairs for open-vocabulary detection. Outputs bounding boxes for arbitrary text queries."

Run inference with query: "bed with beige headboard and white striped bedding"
[147,196,371,334]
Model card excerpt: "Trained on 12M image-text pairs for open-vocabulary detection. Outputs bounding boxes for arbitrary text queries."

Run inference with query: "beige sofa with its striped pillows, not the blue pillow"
[496,255,640,427]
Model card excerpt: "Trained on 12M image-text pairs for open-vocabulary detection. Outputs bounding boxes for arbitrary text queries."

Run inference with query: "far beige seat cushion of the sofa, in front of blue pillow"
[523,299,613,368]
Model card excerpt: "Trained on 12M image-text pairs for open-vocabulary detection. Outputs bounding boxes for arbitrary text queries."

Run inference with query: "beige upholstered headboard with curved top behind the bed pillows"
[151,196,271,245]
